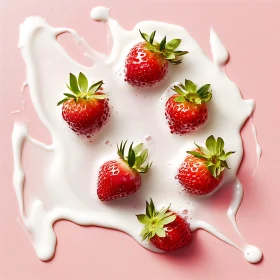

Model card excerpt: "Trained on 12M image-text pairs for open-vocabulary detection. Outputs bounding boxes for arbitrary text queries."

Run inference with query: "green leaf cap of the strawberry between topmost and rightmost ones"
[172,79,212,104]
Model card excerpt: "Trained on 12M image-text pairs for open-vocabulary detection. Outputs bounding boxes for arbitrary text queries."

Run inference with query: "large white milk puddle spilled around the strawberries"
[12,7,262,263]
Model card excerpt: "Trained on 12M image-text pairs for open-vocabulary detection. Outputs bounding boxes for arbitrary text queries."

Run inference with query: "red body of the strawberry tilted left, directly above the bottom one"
[97,160,141,201]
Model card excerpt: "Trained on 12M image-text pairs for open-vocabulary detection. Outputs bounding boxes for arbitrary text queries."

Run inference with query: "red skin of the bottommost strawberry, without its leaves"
[150,210,192,251]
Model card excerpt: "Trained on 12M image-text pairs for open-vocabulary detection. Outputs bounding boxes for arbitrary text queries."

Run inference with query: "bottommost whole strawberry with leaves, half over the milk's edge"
[136,199,192,251]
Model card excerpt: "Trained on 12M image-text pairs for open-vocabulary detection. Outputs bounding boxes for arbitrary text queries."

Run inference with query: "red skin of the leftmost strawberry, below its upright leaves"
[62,95,110,136]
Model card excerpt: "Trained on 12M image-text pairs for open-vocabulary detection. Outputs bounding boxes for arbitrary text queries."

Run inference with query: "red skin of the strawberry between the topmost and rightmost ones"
[165,94,208,135]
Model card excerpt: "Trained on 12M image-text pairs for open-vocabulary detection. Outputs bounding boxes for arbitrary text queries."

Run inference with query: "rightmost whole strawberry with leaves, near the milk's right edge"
[176,135,235,195]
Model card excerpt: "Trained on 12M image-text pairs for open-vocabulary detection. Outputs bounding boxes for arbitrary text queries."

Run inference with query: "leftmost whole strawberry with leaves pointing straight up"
[57,73,109,137]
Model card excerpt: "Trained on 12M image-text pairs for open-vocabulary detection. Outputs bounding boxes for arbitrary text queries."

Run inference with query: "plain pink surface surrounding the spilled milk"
[0,0,280,280]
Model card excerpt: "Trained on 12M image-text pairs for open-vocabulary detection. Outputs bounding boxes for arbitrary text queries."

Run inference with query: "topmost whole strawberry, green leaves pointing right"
[125,30,188,87]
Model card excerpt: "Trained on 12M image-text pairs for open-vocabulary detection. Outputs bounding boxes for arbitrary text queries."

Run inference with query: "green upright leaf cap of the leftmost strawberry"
[57,72,107,106]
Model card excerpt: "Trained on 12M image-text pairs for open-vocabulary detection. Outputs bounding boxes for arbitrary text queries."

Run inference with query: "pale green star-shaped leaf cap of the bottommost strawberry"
[136,198,176,241]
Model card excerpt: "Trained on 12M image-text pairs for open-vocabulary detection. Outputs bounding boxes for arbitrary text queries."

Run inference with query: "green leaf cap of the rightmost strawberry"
[187,135,235,178]
